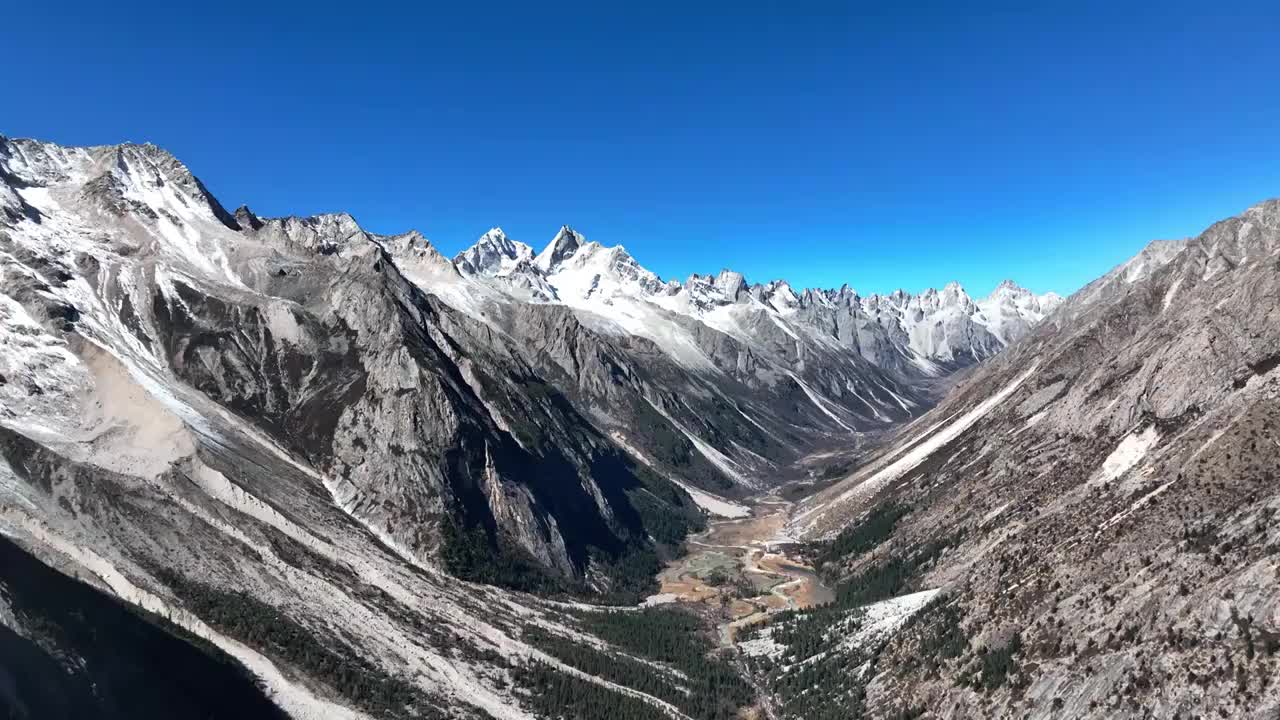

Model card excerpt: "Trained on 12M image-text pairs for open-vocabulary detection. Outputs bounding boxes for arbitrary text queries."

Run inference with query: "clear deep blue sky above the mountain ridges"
[0,1,1280,293]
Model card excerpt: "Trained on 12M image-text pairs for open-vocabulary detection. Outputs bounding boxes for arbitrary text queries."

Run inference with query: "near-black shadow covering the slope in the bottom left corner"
[0,537,285,720]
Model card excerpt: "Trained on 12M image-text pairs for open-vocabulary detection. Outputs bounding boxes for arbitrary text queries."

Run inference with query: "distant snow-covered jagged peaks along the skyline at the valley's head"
[445,225,1062,377]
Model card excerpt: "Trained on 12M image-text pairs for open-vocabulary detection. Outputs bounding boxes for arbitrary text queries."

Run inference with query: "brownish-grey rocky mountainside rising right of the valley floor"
[747,201,1280,717]
